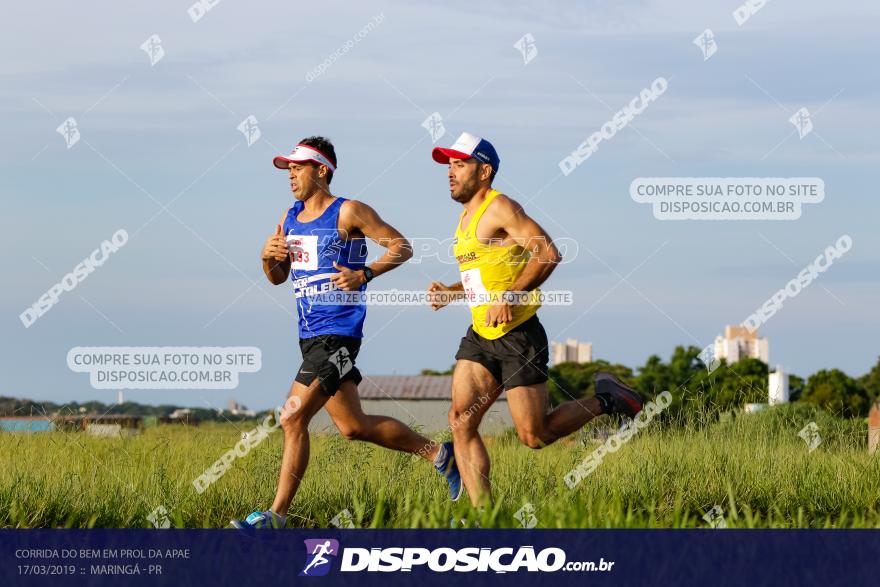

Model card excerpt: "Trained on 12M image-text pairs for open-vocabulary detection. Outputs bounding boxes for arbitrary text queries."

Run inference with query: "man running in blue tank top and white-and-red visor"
[232,137,461,528]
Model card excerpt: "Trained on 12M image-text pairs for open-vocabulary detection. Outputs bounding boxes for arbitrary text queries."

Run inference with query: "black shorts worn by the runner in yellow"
[455,314,550,389]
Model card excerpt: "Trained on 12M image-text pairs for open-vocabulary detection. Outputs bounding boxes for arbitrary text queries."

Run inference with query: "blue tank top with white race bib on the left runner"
[283,197,367,338]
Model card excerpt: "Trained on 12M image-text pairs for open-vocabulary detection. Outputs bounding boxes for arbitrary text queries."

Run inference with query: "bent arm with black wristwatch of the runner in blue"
[330,200,412,290]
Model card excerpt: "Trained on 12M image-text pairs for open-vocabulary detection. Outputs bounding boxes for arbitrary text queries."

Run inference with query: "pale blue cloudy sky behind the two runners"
[0,0,880,408]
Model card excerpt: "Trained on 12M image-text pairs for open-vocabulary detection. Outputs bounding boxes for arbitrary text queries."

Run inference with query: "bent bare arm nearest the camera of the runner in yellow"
[488,195,562,291]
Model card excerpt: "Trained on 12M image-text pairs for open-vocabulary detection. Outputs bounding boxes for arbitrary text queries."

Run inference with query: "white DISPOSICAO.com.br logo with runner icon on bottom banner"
[300,539,614,576]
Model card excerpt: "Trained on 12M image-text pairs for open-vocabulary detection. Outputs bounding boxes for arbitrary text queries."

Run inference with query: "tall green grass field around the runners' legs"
[0,406,880,528]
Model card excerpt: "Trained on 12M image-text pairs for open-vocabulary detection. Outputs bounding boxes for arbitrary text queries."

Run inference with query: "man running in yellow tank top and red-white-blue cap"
[428,133,642,505]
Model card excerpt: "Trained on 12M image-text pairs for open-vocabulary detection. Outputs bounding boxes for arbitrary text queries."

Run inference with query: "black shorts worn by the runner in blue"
[296,334,362,396]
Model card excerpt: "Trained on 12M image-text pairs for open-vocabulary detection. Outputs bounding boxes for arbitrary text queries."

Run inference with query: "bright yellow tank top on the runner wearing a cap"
[453,190,541,340]
